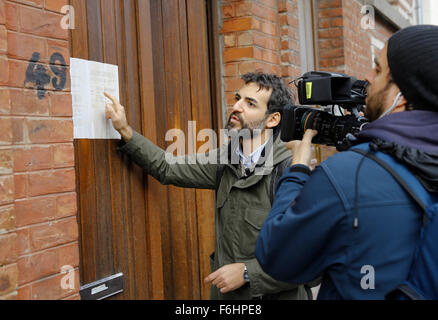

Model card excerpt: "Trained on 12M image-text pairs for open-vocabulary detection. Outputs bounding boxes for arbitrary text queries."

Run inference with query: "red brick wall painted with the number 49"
[0,0,79,299]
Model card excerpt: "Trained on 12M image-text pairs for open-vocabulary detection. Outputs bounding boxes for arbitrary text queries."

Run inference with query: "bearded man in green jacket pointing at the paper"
[105,73,309,299]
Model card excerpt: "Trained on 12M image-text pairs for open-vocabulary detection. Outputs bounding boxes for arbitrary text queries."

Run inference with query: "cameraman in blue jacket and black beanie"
[256,25,438,299]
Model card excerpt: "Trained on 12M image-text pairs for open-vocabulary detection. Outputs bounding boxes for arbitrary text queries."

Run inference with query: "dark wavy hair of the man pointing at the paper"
[242,72,295,115]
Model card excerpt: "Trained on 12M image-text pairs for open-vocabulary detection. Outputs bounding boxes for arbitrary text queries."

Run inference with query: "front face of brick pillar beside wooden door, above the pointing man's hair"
[220,0,280,110]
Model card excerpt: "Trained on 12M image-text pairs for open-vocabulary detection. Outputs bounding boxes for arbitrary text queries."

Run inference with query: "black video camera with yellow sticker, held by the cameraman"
[281,71,368,151]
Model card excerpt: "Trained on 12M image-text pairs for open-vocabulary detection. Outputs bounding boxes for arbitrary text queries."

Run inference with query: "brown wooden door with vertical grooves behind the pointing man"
[70,0,220,299]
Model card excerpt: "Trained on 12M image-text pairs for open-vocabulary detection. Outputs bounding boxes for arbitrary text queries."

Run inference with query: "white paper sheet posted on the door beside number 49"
[70,58,121,139]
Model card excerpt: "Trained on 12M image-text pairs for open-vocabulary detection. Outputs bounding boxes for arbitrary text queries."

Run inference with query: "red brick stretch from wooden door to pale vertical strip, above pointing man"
[220,0,299,112]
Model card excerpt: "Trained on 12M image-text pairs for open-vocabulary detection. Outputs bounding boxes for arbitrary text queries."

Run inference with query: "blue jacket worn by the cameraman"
[256,110,438,299]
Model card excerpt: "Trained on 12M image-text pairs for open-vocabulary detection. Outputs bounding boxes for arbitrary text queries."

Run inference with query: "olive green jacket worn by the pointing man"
[118,132,307,300]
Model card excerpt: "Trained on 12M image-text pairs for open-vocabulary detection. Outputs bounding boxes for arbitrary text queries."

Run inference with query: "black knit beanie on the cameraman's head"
[388,25,438,111]
